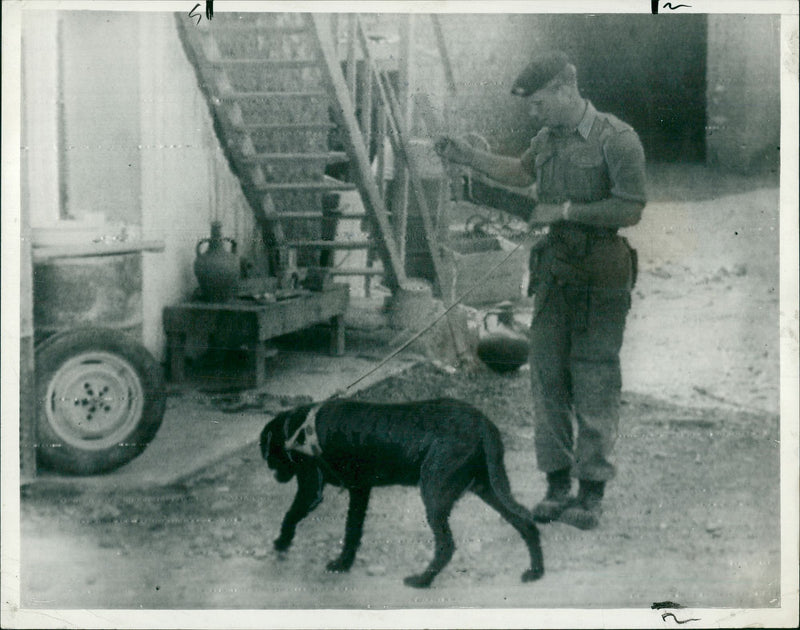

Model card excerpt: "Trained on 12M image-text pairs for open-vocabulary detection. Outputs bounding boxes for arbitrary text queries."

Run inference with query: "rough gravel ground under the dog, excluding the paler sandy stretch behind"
[22,364,780,609]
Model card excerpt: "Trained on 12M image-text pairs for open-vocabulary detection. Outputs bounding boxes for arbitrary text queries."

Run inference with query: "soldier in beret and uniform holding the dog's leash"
[436,52,646,529]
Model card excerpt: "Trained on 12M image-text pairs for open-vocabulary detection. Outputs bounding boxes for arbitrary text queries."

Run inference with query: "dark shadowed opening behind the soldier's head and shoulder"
[551,14,708,162]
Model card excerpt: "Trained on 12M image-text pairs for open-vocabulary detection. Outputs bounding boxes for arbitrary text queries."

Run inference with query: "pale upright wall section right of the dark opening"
[707,15,780,172]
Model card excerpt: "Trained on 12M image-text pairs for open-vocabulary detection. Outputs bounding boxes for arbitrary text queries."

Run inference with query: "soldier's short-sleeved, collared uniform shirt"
[521,101,646,203]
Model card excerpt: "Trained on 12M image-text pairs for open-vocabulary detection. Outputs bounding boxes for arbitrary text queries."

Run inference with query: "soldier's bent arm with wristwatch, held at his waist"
[566,131,647,228]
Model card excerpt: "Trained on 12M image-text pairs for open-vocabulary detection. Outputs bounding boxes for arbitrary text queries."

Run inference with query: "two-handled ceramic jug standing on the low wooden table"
[194,221,240,302]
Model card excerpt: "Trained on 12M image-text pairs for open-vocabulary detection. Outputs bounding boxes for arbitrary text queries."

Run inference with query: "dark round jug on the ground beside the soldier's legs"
[478,302,528,373]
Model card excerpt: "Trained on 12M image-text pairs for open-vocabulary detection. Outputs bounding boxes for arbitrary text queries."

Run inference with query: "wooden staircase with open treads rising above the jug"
[176,13,404,288]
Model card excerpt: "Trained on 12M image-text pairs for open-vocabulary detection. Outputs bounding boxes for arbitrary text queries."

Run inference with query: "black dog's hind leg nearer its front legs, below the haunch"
[403,452,471,588]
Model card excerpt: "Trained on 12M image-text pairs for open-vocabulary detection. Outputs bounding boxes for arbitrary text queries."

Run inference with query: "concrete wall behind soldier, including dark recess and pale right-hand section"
[384,14,780,171]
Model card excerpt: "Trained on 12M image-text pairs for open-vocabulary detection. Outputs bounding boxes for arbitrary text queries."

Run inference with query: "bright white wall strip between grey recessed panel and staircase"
[138,13,255,359]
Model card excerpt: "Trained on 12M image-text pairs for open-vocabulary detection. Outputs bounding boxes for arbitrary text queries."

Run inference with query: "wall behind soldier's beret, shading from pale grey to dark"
[428,14,706,160]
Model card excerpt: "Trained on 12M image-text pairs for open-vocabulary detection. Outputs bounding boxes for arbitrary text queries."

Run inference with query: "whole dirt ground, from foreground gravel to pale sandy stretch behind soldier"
[15,167,781,625]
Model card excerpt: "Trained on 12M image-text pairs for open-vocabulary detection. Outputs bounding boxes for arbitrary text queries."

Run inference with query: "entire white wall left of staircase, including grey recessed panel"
[23,11,262,360]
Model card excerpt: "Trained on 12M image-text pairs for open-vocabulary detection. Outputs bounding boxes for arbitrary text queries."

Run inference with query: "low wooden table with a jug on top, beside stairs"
[163,284,350,387]
